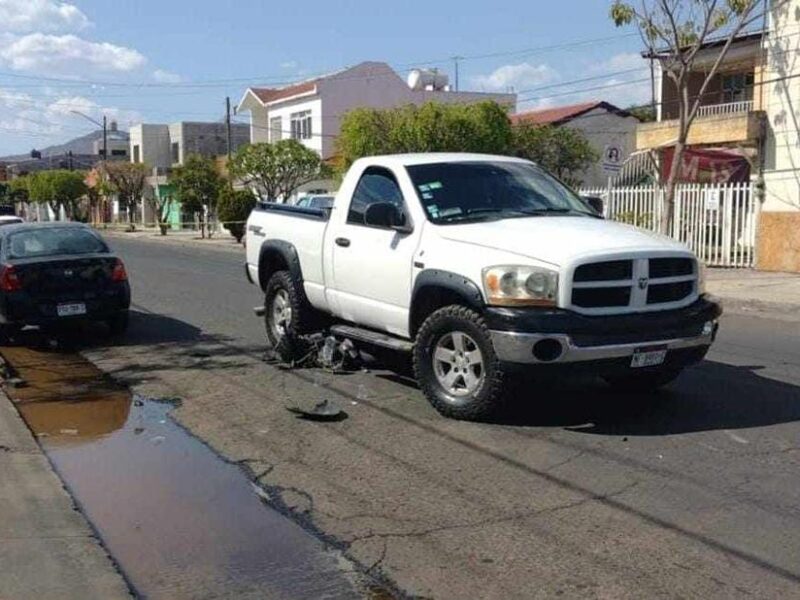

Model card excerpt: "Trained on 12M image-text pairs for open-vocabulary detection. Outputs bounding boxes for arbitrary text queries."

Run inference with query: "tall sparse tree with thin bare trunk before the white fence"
[610,0,768,234]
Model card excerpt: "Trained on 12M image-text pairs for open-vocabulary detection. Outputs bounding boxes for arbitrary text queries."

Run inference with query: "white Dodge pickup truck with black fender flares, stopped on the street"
[246,154,721,419]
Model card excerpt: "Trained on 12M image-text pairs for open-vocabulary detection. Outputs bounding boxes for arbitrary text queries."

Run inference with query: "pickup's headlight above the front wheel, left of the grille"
[483,265,558,306]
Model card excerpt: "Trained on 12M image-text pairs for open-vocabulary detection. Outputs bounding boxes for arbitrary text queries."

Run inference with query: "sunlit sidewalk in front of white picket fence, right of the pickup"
[706,269,800,321]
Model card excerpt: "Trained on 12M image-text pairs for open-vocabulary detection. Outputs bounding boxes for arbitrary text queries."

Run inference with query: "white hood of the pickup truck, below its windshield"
[437,216,687,265]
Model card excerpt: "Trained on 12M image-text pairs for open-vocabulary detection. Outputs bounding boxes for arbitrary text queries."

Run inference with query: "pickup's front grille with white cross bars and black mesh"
[570,256,697,312]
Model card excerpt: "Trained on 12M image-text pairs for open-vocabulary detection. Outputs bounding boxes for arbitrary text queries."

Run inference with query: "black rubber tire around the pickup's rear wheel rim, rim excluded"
[264,271,314,363]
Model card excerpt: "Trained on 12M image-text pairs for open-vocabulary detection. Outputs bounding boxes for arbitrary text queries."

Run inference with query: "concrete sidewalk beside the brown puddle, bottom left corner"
[0,391,131,600]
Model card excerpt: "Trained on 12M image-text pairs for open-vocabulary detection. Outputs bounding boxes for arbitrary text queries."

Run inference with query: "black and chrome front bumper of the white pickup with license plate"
[487,298,722,365]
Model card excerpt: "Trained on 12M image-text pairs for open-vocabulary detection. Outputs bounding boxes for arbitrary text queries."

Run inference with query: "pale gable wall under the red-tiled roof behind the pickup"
[564,108,639,187]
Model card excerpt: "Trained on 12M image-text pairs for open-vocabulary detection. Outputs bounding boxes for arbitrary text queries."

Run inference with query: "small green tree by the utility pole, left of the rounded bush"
[169,154,225,238]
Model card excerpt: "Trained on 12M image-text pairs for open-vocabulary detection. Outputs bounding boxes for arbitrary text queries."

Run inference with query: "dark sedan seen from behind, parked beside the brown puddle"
[0,223,131,335]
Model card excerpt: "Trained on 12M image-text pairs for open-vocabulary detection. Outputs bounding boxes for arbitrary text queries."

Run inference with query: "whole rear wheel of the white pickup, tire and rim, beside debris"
[264,271,311,362]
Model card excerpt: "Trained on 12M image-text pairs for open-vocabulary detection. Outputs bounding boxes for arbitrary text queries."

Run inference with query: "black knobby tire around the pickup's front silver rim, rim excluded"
[413,304,506,421]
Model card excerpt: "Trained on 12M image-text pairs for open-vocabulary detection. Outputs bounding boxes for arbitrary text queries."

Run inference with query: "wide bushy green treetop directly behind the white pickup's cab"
[337,102,513,169]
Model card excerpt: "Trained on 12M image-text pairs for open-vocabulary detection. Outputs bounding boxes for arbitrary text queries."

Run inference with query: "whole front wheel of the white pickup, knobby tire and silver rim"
[414,305,504,421]
